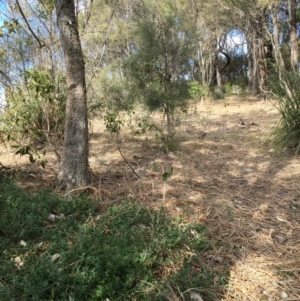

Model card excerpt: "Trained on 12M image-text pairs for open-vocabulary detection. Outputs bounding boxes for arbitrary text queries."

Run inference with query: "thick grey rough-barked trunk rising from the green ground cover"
[55,0,89,190]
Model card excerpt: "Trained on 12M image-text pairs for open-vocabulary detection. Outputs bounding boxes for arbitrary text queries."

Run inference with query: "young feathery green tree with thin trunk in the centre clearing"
[124,2,190,136]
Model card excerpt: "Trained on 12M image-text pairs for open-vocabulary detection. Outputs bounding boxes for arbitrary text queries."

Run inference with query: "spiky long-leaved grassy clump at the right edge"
[269,71,300,153]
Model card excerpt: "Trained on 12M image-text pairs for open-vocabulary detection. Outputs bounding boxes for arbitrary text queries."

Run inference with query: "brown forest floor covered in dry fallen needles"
[0,97,300,301]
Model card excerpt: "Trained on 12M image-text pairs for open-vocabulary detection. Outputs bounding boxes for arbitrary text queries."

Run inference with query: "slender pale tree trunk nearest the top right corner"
[288,0,298,72]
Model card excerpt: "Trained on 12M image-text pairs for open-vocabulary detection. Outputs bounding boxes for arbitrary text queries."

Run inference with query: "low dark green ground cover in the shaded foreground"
[0,179,226,301]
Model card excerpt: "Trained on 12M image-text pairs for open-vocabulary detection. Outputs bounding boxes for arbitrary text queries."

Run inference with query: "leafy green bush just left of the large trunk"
[1,69,66,162]
